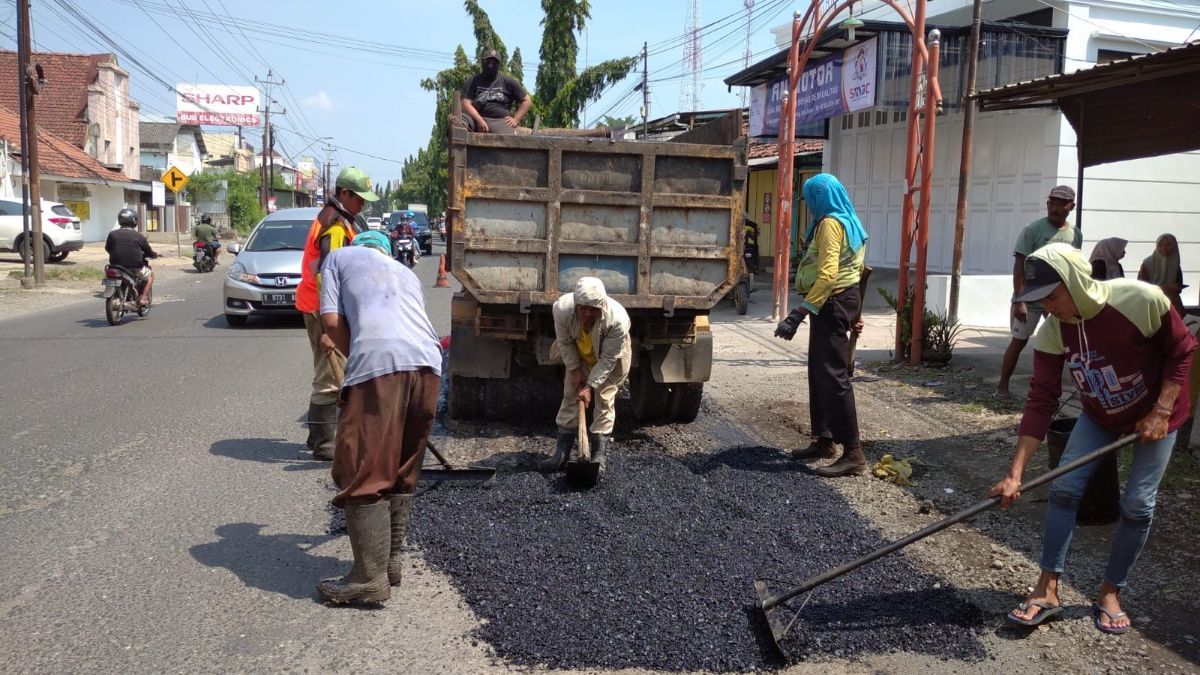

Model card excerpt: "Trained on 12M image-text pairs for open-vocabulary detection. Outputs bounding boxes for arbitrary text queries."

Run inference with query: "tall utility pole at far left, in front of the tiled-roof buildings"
[17,0,46,288]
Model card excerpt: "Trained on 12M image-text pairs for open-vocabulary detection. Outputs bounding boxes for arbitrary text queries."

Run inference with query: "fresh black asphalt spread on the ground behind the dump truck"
[410,448,984,671]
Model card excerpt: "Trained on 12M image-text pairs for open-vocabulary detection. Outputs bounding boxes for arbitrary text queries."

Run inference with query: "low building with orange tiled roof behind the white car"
[0,107,150,241]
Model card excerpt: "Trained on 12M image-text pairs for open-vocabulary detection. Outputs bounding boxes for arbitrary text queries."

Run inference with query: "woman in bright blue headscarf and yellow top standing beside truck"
[775,173,868,478]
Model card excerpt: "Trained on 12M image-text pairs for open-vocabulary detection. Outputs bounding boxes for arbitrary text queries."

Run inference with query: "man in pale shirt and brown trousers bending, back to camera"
[317,231,442,603]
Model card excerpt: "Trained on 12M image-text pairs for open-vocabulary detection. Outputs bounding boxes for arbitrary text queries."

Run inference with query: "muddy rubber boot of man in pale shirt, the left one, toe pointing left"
[317,500,391,604]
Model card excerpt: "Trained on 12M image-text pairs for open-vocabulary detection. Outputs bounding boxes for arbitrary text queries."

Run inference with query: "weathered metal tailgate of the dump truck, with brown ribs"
[448,129,746,316]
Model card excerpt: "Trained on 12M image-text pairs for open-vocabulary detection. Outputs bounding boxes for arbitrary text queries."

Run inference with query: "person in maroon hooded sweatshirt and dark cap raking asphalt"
[988,244,1196,634]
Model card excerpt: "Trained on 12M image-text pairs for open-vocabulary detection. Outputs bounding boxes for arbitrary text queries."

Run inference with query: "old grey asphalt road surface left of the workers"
[0,240,455,673]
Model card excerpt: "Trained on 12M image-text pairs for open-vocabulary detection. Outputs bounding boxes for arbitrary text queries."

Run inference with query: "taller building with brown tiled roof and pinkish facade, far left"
[0,50,139,180]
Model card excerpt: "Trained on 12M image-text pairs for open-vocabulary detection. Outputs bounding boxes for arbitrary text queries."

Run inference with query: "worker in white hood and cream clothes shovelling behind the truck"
[542,276,632,471]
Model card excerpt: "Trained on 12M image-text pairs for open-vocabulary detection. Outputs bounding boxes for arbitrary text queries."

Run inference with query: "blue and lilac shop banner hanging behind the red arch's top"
[750,38,878,136]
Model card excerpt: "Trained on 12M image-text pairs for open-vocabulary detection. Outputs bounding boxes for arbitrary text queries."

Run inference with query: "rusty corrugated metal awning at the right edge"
[978,41,1200,167]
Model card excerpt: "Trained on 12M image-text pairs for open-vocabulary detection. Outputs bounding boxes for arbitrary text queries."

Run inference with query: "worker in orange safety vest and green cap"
[296,167,379,461]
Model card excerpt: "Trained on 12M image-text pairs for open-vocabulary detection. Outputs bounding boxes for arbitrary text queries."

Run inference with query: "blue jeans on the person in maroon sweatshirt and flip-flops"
[1042,414,1175,589]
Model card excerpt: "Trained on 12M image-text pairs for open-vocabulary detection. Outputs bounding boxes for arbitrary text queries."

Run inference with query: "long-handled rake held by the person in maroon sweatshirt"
[754,434,1138,656]
